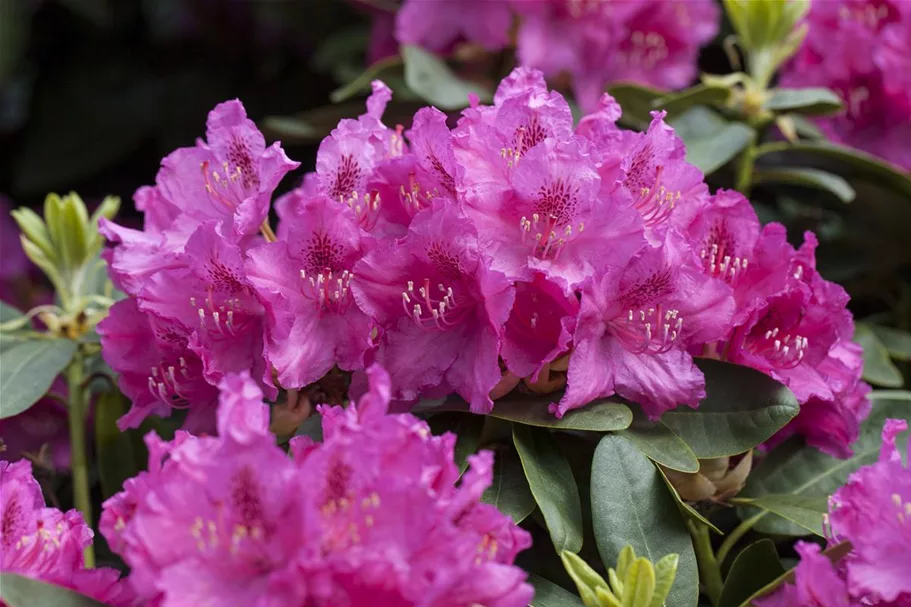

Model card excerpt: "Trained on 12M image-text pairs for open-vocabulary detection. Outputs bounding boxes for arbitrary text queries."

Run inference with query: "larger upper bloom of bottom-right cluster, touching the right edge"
[829,420,911,605]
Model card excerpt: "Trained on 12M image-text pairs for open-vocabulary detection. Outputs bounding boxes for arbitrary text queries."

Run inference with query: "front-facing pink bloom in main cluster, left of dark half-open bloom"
[351,200,514,412]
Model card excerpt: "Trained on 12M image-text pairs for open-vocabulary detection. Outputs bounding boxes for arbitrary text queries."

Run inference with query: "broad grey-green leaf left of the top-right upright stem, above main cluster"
[671,106,755,175]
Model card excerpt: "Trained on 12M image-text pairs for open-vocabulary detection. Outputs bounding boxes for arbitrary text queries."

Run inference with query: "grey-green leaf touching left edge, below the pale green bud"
[0,339,76,419]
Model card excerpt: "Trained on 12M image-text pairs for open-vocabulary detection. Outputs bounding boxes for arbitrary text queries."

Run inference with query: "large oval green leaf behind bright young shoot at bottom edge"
[591,434,699,606]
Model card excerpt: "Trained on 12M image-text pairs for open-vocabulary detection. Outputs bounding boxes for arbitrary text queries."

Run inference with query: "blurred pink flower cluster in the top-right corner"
[781,0,911,170]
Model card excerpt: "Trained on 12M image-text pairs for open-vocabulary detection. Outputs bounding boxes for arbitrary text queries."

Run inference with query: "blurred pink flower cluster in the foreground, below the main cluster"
[101,366,533,607]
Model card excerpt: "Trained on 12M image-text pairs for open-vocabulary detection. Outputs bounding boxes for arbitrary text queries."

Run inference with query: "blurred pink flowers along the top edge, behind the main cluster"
[390,0,721,109]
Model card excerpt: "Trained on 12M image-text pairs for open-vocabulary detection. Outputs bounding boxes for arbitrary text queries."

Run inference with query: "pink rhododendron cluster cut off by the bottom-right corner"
[759,420,911,607]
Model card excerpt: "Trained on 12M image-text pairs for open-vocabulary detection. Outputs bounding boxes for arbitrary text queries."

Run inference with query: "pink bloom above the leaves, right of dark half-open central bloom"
[551,230,733,419]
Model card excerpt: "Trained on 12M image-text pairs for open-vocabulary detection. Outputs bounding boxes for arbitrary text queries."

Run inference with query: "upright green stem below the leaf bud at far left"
[66,350,95,568]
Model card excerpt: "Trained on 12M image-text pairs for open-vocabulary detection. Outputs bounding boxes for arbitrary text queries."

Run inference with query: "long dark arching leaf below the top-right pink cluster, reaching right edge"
[756,141,911,197]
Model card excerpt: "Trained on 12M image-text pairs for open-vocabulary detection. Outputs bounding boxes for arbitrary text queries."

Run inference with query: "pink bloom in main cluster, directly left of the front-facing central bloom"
[246,196,372,388]
